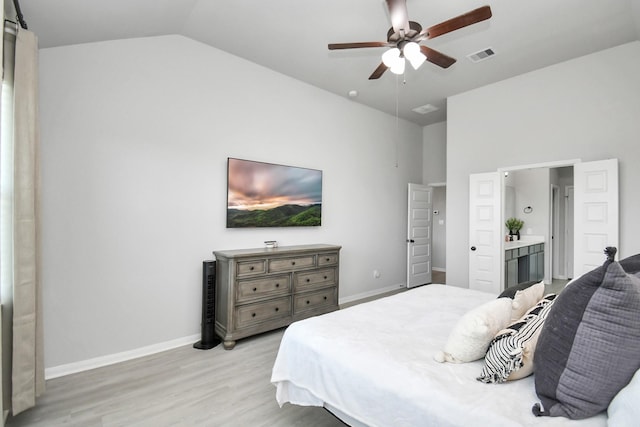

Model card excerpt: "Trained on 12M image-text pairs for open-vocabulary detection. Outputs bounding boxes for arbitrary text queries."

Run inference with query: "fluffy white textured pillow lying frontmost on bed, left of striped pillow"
[434,298,512,363]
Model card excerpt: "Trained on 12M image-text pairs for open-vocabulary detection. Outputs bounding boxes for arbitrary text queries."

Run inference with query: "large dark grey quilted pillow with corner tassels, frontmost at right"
[532,248,640,419]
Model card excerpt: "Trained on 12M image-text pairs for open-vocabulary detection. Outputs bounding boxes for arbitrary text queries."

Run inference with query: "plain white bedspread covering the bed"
[271,285,606,427]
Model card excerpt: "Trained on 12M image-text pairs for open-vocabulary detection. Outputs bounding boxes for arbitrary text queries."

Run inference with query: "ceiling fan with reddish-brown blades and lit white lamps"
[329,0,491,80]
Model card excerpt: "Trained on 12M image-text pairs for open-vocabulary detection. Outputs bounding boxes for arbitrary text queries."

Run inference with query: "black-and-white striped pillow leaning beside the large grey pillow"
[477,294,556,383]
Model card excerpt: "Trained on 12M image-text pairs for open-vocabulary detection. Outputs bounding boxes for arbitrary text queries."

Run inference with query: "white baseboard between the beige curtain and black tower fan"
[44,335,201,380]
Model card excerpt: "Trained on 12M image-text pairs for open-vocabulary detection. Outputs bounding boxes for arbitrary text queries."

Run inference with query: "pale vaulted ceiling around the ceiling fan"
[8,0,640,125]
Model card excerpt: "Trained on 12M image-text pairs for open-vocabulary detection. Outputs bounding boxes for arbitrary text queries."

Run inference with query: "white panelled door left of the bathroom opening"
[469,172,504,293]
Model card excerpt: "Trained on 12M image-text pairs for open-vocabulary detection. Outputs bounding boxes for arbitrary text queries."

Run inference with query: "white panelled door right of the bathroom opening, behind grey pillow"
[573,159,618,277]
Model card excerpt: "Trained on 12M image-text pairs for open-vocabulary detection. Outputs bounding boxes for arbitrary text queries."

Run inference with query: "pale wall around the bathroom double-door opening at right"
[447,41,640,287]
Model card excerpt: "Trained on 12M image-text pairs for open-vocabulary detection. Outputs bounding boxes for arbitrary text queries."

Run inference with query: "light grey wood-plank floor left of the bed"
[7,329,344,427]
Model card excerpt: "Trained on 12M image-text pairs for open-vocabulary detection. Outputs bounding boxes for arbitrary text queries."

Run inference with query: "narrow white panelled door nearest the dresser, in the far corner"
[407,184,433,288]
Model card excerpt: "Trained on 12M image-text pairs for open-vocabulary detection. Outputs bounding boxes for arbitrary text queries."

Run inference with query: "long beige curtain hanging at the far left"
[3,25,44,415]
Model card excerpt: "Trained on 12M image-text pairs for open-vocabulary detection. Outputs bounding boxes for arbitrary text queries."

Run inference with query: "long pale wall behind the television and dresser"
[40,36,422,372]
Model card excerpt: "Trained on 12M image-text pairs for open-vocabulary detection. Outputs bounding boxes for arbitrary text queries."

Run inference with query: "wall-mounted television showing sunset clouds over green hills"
[227,157,322,228]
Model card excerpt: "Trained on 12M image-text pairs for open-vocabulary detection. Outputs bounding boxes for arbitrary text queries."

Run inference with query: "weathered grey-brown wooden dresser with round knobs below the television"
[213,244,341,350]
